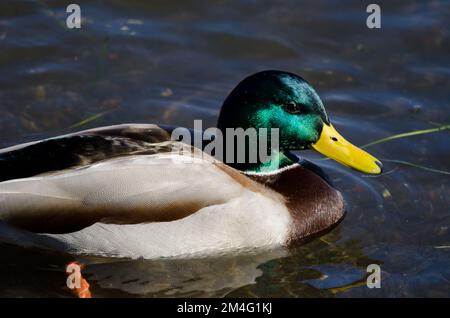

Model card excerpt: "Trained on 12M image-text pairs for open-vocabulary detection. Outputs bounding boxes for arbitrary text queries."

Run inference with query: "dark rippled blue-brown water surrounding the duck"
[0,0,450,297]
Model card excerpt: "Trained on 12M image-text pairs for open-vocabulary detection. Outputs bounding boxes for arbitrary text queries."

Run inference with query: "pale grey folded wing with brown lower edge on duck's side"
[0,147,248,233]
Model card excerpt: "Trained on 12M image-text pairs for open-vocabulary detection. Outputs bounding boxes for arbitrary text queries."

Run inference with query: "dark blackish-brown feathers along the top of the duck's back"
[0,124,176,182]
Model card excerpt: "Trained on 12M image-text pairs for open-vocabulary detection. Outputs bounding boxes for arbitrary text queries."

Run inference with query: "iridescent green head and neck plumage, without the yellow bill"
[217,71,329,171]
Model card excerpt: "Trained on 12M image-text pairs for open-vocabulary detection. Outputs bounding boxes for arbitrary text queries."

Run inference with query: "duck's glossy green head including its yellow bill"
[217,71,381,174]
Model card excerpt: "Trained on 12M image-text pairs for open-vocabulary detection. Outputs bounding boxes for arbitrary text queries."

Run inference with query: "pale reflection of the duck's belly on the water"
[85,250,286,297]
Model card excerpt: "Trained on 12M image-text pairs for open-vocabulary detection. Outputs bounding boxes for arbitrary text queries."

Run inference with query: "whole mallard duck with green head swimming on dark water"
[0,71,381,258]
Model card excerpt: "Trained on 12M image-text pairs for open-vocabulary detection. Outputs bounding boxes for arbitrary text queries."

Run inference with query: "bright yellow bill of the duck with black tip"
[311,124,383,174]
